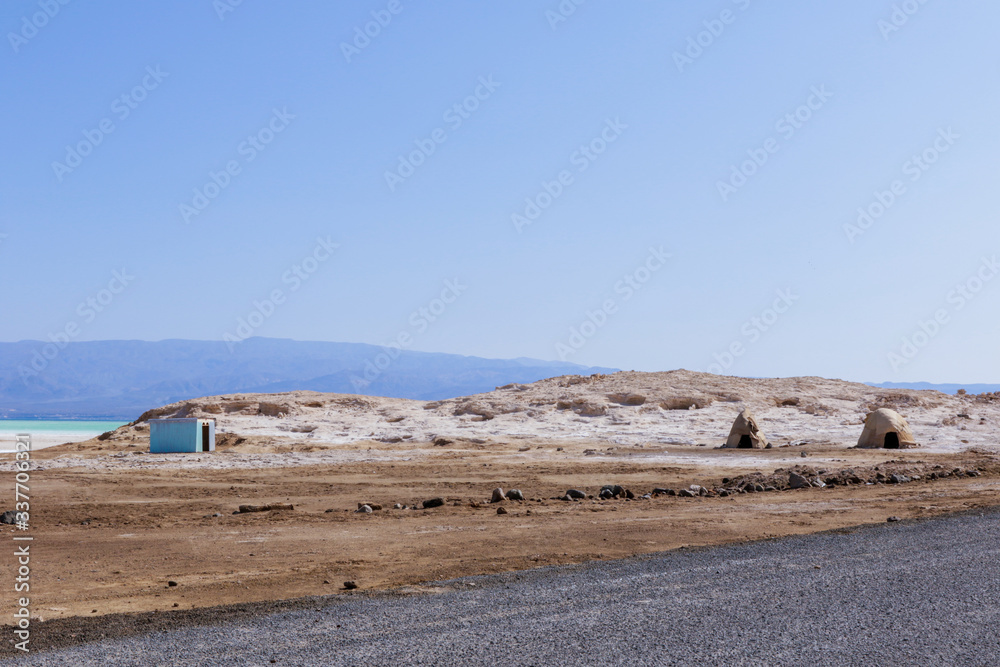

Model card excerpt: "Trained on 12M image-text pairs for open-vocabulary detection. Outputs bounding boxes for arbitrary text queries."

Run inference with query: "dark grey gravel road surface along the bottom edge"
[9,510,1000,666]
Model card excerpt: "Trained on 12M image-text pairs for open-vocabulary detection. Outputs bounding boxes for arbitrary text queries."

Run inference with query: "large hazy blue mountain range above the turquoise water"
[0,338,617,420]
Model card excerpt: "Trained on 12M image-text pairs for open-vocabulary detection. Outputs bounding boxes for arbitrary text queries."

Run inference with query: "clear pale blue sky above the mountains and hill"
[0,0,1000,382]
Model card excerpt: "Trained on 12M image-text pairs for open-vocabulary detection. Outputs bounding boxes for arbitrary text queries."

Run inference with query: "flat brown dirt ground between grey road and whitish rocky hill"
[0,442,1000,656]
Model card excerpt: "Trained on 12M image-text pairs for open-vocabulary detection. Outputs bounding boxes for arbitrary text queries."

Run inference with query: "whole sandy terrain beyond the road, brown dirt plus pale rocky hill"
[0,372,1000,652]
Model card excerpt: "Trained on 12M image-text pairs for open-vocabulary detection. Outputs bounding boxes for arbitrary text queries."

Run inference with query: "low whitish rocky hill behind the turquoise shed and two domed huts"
[99,370,1000,451]
